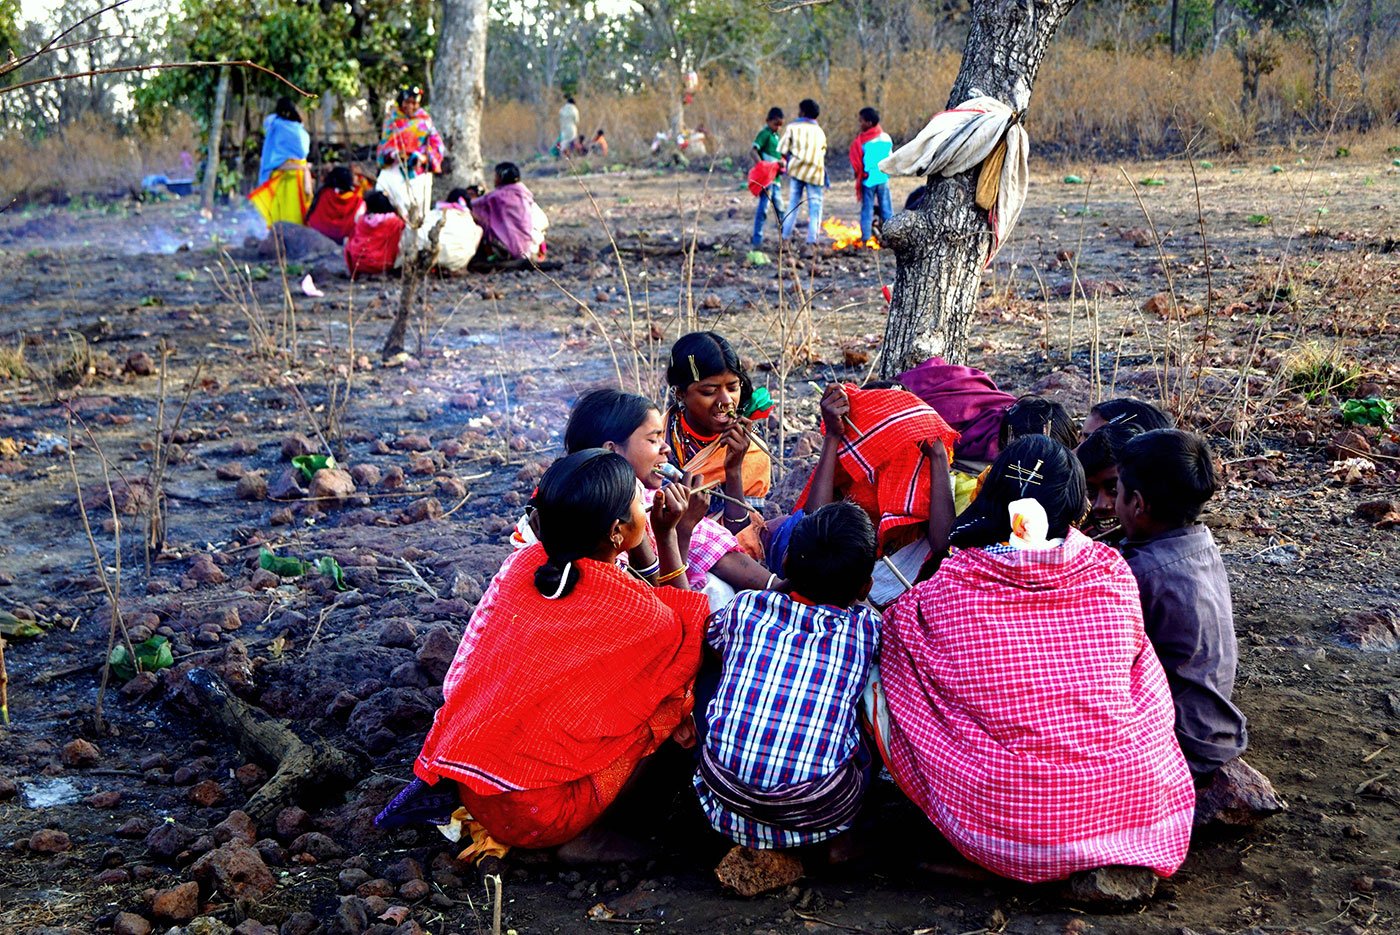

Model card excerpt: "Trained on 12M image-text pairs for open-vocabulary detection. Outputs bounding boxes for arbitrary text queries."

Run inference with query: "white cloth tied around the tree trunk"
[879,97,1030,263]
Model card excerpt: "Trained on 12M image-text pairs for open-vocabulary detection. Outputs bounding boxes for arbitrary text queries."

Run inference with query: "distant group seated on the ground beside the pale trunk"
[284,162,549,279]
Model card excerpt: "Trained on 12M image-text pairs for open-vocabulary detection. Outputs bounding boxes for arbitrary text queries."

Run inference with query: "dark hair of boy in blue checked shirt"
[783,500,875,607]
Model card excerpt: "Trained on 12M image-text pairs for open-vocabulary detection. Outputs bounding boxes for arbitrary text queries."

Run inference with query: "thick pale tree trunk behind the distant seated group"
[433,0,490,188]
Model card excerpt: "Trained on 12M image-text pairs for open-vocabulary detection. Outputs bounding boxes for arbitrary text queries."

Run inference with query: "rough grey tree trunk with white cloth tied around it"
[881,0,1075,379]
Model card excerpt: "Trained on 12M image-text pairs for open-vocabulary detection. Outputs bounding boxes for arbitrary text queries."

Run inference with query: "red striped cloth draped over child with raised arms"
[797,384,958,554]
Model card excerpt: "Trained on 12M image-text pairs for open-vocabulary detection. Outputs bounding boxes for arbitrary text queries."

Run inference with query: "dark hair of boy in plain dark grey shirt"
[1119,428,1219,528]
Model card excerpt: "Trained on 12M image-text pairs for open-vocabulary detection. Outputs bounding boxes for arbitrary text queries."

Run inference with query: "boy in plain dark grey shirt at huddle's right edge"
[1116,428,1249,781]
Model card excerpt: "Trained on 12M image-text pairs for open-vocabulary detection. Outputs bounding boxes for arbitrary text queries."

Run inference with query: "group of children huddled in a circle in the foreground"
[379,332,1271,882]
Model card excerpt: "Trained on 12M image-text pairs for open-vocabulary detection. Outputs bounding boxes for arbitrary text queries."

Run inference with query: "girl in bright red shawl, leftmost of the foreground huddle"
[377,448,708,859]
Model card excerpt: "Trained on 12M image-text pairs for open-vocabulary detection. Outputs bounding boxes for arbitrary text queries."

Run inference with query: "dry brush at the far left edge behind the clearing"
[0,113,199,202]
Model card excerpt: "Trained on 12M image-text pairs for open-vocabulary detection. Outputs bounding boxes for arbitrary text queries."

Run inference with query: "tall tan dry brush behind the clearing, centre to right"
[483,41,1400,165]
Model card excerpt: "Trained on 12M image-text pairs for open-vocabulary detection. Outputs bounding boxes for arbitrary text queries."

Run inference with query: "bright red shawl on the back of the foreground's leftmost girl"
[414,544,708,847]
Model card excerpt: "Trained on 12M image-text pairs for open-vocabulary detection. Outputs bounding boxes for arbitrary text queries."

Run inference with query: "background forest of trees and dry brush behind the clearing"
[0,0,1400,200]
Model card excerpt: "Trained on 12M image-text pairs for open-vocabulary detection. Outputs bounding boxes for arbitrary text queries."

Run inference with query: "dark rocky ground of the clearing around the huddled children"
[0,146,1400,935]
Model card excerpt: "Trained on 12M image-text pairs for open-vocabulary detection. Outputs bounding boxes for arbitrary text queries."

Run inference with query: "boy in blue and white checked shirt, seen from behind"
[694,501,879,848]
